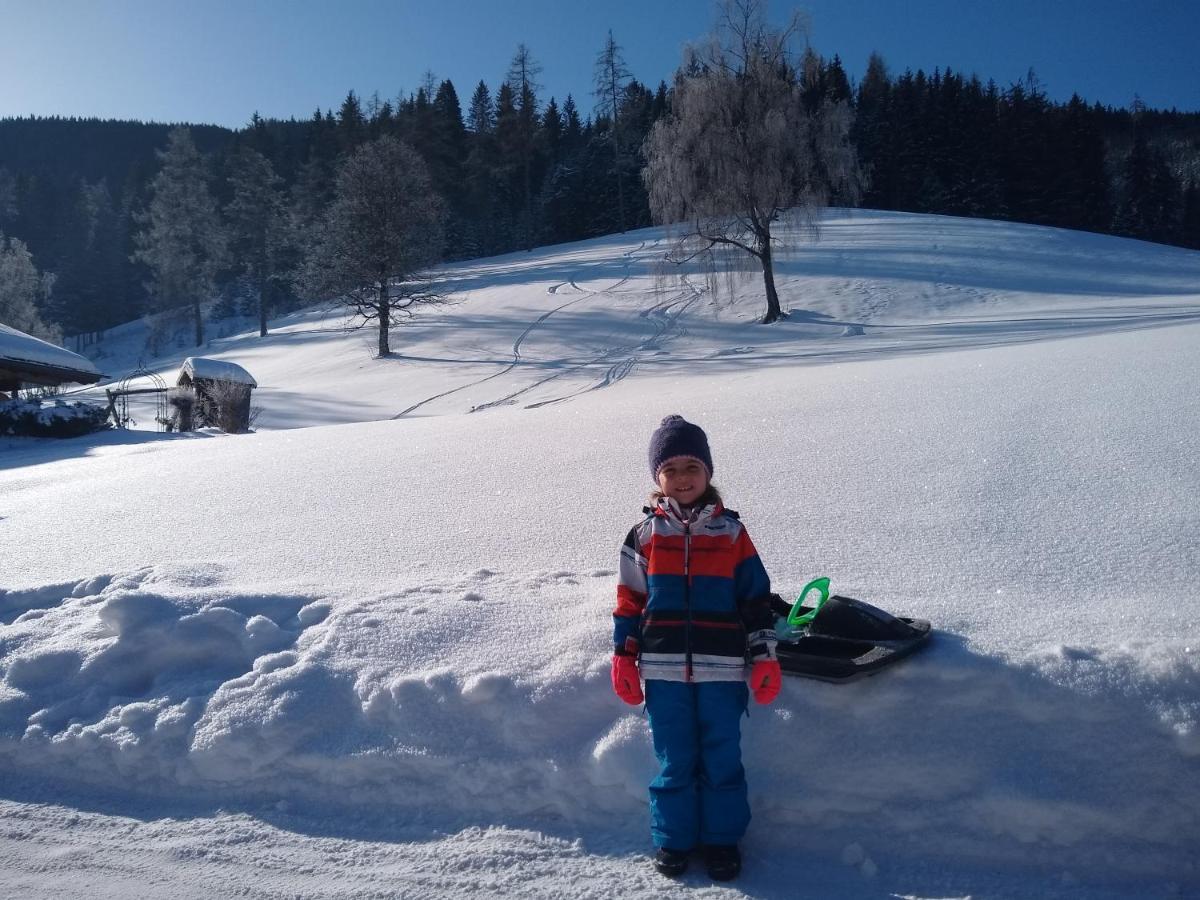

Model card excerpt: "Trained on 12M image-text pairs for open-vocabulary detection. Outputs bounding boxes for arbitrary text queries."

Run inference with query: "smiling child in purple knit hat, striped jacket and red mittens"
[612,415,781,881]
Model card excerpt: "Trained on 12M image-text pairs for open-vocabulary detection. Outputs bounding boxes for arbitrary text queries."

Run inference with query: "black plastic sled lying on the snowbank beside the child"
[770,594,930,683]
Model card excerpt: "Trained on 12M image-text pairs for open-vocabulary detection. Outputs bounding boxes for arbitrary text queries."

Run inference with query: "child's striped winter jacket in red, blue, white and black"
[613,498,775,682]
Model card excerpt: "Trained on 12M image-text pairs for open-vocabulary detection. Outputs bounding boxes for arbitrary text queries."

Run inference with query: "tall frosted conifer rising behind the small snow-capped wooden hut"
[134,127,227,346]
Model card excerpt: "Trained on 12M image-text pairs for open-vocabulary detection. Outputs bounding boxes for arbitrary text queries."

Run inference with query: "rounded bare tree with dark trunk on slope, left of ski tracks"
[302,136,444,358]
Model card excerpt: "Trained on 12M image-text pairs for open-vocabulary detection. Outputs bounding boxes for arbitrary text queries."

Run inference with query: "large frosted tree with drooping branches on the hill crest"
[642,0,860,323]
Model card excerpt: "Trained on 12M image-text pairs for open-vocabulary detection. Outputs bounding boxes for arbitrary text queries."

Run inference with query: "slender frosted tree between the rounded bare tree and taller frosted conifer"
[226,148,293,337]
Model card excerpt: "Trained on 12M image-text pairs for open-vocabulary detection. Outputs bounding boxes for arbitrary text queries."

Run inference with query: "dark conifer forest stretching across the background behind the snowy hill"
[0,38,1200,355]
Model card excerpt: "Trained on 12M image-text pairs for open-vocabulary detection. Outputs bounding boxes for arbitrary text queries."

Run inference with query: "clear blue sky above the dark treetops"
[0,0,1200,127]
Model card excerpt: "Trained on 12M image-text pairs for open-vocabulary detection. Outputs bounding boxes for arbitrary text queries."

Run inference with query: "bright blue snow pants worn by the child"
[646,678,750,851]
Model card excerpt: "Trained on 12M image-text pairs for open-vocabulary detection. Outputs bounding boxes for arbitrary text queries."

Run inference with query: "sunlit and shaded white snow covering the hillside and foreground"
[0,210,1200,898]
